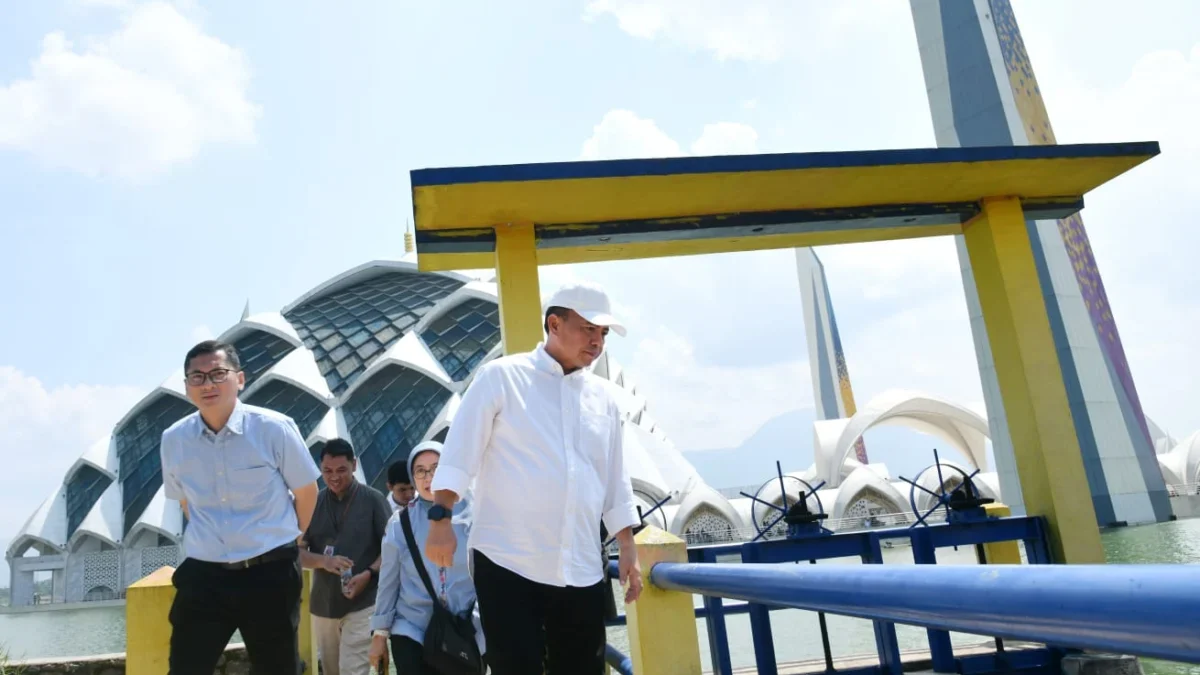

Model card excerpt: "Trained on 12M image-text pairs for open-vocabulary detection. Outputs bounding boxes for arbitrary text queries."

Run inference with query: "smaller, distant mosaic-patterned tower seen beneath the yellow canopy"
[796,249,866,464]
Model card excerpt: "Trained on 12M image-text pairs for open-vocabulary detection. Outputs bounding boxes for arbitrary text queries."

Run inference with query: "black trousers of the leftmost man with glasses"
[168,556,302,675]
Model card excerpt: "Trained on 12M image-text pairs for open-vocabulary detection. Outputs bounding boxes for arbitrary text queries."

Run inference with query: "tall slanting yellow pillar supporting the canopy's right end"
[964,197,1104,563]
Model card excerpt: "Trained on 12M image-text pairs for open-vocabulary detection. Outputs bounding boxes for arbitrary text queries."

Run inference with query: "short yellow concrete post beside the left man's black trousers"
[125,567,175,675]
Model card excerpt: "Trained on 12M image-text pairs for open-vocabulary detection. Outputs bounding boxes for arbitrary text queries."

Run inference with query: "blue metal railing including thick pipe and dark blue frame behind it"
[608,513,1200,675]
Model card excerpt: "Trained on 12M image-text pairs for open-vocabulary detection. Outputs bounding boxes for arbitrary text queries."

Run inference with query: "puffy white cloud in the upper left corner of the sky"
[0,0,262,180]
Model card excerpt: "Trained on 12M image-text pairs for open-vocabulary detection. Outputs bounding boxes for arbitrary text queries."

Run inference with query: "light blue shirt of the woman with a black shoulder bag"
[371,497,487,653]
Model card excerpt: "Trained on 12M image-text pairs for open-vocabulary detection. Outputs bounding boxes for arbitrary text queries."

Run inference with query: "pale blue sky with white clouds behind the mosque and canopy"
[0,0,1200,584]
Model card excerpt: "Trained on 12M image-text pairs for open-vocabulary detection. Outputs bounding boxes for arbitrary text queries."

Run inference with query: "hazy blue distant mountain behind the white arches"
[684,408,994,489]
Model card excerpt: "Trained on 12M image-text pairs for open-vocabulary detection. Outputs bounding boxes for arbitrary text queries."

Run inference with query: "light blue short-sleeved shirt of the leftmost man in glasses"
[161,401,320,562]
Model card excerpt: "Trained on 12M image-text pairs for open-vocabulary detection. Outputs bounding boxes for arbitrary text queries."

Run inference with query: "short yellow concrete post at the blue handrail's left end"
[625,525,701,675]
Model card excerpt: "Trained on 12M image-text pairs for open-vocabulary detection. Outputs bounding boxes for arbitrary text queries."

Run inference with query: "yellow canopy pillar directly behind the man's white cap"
[496,223,544,354]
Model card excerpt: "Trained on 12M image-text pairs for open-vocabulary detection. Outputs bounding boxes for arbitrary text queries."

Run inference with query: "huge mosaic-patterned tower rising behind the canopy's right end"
[910,0,1171,526]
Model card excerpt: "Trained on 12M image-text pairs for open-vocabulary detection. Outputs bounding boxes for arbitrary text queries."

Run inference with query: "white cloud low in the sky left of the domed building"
[0,365,144,585]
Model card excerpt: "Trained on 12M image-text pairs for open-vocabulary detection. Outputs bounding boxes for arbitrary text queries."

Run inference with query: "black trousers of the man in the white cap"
[472,551,612,675]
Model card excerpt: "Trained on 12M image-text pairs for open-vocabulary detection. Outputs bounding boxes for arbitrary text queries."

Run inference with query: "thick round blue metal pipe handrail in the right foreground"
[650,562,1200,663]
